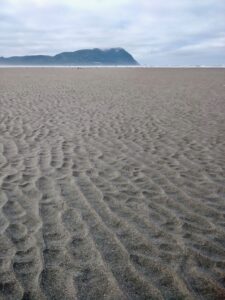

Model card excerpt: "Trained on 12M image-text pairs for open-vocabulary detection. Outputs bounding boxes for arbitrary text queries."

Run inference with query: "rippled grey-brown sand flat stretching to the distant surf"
[0,68,225,300]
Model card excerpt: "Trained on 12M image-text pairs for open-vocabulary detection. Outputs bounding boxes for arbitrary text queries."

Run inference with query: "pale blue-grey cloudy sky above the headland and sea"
[0,0,225,65]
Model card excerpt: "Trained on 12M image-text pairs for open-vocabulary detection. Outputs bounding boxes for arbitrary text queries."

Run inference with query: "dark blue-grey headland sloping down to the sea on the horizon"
[0,48,139,66]
